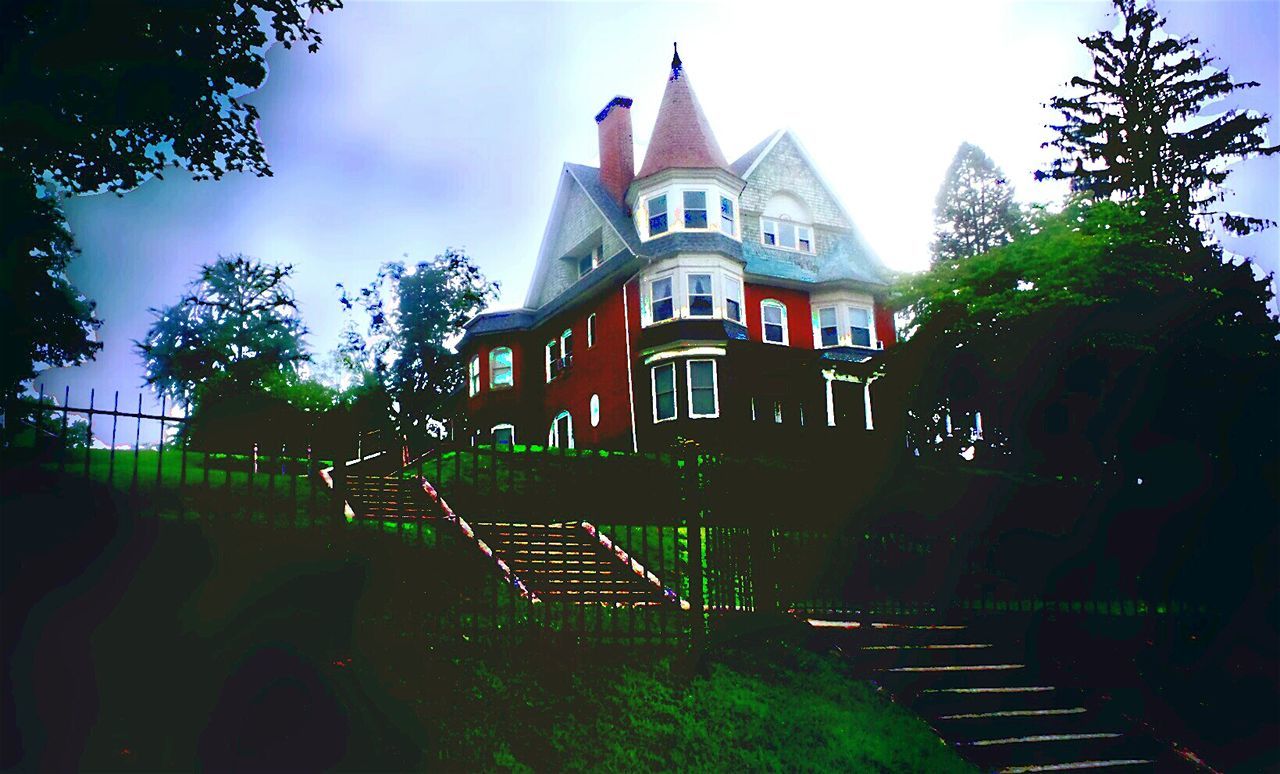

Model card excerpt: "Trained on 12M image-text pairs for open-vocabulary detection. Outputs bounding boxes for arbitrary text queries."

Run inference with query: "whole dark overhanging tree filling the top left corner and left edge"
[0,0,340,404]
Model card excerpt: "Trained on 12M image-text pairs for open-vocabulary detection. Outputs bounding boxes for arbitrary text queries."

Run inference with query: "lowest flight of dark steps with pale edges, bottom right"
[810,618,1212,774]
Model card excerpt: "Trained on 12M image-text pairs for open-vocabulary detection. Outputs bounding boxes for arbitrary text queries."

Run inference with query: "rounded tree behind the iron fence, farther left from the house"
[134,255,308,408]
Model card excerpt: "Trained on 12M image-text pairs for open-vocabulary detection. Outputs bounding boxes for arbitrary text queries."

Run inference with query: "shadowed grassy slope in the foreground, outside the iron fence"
[0,475,969,771]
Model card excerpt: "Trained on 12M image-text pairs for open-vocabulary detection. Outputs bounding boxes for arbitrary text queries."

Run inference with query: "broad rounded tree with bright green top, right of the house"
[888,195,1280,480]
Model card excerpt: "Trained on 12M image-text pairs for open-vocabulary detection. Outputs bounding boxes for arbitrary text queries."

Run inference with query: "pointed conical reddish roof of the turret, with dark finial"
[636,54,728,178]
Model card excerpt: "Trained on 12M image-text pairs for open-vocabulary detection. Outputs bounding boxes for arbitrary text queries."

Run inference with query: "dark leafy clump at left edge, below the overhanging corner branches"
[0,174,102,400]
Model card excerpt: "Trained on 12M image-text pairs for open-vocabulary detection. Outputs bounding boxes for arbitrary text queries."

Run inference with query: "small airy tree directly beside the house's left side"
[338,247,498,435]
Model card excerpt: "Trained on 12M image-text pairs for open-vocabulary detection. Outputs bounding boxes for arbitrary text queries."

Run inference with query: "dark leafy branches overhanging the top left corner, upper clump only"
[0,0,340,193]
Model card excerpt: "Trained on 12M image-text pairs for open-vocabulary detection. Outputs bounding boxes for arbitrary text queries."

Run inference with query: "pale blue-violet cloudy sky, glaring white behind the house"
[37,0,1280,422]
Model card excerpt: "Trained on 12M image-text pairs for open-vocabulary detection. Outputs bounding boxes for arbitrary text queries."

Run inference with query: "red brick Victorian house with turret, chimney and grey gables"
[457,49,895,450]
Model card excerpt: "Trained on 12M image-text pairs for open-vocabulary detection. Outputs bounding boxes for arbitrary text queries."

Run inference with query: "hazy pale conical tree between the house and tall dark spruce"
[933,142,1021,264]
